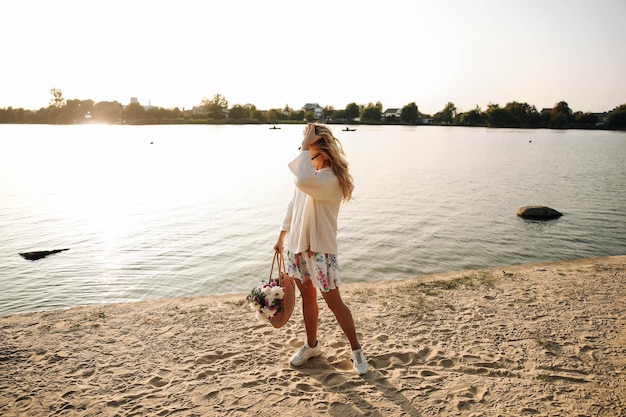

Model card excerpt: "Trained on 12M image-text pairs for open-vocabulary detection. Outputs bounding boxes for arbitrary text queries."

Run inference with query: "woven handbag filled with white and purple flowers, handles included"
[246,252,296,328]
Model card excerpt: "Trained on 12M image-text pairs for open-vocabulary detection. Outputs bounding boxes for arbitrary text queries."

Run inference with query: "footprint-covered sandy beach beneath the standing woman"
[0,256,626,417]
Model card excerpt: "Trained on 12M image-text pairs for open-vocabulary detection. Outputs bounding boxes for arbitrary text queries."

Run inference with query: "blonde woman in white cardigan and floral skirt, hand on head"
[274,123,367,375]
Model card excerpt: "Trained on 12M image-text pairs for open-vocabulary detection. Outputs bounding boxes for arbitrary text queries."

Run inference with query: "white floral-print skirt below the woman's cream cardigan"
[286,249,339,292]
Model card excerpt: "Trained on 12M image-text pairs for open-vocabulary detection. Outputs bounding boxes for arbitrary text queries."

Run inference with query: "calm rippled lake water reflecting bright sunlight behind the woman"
[0,125,626,315]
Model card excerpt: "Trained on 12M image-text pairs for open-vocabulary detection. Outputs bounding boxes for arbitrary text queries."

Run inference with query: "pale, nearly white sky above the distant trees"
[0,0,626,114]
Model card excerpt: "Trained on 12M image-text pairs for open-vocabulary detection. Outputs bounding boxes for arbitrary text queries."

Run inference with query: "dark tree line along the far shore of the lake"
[0,88,626,129]
